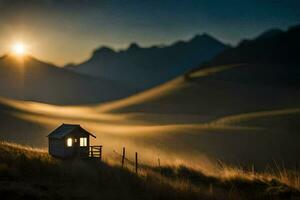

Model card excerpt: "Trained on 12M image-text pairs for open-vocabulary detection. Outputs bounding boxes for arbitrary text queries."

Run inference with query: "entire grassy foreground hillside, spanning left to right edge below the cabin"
[0,142,300,199]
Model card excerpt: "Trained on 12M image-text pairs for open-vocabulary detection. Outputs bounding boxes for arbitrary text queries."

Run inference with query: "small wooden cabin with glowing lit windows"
[48,124,101,158]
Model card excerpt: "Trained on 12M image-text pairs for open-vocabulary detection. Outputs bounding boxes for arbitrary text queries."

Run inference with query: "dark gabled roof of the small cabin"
[48,124,96,139]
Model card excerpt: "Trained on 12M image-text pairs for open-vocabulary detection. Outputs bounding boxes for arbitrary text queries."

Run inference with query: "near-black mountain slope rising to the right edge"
[186,26,300,86]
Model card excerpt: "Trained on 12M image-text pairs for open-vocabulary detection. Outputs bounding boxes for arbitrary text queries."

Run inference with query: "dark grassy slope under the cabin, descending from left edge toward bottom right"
[0,142,206,199]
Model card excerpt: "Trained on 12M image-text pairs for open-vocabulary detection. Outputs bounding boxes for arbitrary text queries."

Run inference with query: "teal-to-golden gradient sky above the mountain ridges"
[0,0,300,66]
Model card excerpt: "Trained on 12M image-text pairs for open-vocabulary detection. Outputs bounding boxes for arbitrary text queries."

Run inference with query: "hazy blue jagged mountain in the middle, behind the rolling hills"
[68,34,228,89]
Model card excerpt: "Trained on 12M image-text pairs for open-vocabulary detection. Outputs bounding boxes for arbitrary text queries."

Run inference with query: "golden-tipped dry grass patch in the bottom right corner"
[150,166,300,199]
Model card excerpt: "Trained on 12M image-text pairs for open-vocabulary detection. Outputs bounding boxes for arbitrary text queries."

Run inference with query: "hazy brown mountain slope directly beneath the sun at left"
[0,55,133,104]
